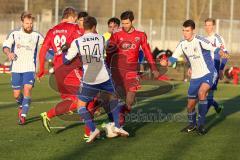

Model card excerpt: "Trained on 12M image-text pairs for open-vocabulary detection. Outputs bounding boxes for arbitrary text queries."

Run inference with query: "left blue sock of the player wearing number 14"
[78,107,96,132]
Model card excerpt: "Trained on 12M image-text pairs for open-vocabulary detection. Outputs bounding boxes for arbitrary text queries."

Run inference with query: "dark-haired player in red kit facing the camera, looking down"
[106,11,159,124]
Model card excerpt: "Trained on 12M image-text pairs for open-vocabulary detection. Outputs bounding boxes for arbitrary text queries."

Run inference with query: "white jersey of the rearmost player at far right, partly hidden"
[206,33,227,60]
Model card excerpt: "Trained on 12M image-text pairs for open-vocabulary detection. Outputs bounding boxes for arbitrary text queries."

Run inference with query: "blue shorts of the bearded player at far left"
[11,72,35,90]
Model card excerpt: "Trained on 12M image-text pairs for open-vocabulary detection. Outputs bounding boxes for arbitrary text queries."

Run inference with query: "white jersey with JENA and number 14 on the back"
[65,33,110,85]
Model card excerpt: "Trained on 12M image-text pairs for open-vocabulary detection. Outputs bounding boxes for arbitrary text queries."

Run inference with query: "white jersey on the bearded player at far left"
[3,28,44,73]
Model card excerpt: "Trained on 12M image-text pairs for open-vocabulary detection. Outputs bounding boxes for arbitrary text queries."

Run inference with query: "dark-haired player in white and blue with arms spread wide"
[160,20,226,135]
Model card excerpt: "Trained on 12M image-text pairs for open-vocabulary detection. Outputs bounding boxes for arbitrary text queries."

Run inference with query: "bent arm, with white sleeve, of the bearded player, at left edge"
[3,32,16,61]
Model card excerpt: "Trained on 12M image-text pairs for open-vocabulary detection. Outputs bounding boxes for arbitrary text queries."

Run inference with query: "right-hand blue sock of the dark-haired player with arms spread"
[198,100,208,126]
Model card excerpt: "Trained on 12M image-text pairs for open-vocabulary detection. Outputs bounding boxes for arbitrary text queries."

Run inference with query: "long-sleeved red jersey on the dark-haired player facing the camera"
[106,29,157,71]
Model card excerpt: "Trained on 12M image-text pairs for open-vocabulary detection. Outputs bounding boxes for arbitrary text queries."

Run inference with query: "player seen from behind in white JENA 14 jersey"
[64,16,129,143]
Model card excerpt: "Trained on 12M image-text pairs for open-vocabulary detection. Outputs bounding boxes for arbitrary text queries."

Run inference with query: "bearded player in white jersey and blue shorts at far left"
[3,12,43,125]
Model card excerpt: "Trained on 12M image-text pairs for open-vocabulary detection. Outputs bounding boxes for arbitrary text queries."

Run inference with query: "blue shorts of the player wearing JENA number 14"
[78,79,115,102]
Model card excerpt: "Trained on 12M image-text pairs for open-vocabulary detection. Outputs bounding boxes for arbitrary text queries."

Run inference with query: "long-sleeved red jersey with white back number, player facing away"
[39,22,83,71]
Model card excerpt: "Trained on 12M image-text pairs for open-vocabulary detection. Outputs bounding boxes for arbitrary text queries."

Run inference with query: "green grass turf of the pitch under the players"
[0,74,240,160]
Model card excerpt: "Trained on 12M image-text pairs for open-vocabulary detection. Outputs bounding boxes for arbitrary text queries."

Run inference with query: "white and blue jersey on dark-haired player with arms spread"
[172,35,217,79]
